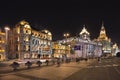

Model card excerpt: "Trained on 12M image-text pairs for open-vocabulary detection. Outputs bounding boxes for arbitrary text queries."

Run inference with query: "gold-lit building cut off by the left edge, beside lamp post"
[0,29,6,61]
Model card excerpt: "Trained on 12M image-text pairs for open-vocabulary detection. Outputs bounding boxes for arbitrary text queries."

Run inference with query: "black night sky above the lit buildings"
[0,0,120,44]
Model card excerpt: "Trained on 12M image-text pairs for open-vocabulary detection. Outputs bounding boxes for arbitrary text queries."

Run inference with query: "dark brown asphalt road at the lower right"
[65,58,120,80]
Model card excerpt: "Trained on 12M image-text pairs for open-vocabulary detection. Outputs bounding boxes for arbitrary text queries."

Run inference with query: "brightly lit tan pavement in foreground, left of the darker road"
[0,60,95,80]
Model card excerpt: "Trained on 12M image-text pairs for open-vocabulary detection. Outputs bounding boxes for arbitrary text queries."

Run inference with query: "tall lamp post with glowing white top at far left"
[4,26,10,60]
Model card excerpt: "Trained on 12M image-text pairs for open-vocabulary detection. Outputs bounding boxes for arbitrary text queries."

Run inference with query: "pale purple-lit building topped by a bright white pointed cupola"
[59,25,102,59]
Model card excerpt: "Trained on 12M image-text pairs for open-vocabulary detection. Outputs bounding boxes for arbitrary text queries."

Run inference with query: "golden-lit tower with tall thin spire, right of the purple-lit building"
[97,23,111,53]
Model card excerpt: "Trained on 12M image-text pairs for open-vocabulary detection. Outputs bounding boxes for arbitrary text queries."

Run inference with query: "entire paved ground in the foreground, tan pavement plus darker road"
[0,58,120,80]
